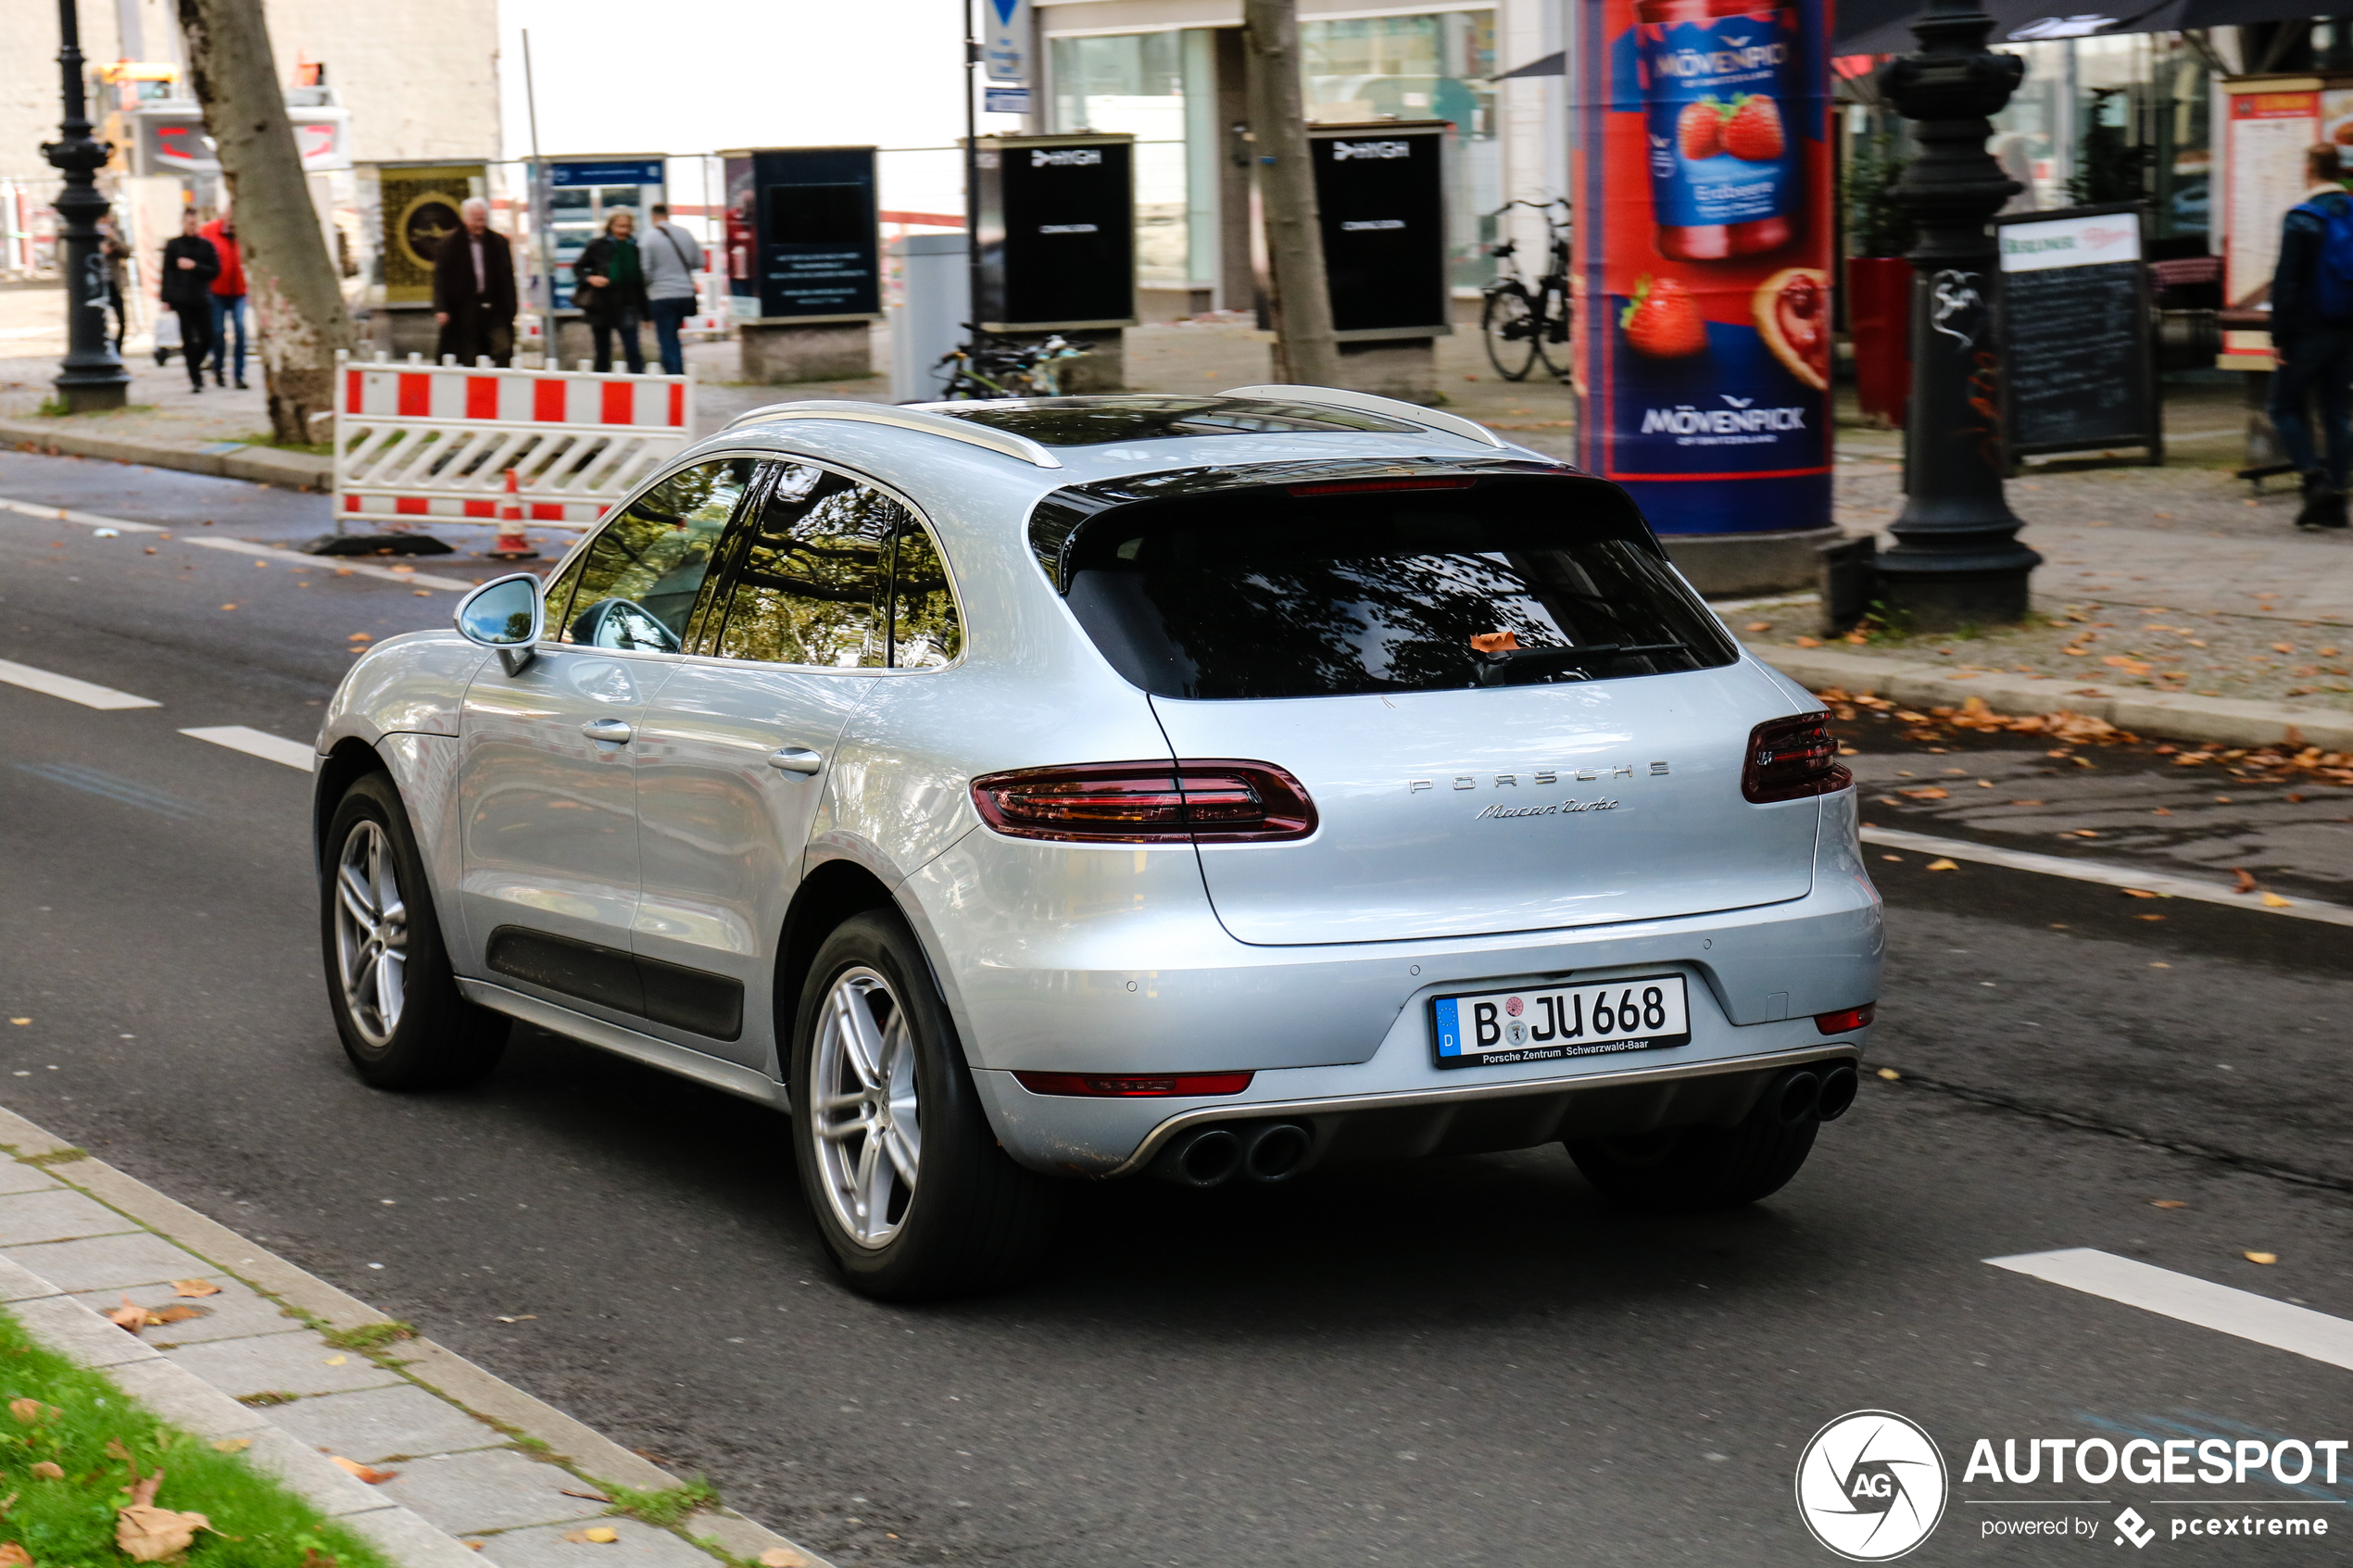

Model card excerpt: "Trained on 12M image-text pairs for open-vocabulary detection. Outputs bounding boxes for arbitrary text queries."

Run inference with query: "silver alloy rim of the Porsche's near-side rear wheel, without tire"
[807,966,923,1246]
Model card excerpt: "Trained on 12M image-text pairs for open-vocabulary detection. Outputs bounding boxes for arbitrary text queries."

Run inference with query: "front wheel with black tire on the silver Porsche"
[318,773,510,1088]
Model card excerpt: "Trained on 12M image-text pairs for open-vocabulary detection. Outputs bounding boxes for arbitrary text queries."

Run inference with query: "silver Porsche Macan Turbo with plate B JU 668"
[315,385,1880,1298]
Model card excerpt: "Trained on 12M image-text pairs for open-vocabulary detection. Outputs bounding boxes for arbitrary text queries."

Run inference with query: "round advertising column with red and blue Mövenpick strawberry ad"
[1569,0,1835,593]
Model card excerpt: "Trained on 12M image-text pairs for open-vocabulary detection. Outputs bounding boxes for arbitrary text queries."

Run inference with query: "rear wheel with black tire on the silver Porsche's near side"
[786,909,1059,1302]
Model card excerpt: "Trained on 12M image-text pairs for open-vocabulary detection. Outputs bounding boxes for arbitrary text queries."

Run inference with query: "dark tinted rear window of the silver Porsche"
[1063,477,1739,700]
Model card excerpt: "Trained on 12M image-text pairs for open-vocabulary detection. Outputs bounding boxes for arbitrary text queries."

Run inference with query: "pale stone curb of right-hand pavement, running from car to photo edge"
[1748,642,2353,750]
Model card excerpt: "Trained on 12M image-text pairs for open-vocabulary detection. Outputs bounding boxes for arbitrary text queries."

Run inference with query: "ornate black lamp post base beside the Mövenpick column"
[1878,0,2043,633]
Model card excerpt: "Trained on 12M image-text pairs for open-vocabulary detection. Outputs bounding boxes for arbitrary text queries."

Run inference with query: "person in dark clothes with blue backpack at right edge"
[2271,141,2353,540]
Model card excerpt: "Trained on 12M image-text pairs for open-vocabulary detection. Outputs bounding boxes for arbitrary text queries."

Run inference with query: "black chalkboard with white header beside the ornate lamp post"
[1994,202,2165,472]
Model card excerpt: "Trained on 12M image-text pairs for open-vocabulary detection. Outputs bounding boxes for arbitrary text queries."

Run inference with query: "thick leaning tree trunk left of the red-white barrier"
[179,0,350,442]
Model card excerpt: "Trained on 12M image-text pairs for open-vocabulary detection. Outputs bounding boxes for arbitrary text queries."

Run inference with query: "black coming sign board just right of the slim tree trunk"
[1308,119,1454,344]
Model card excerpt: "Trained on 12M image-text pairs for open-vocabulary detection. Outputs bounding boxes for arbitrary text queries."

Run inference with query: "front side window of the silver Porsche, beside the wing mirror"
[548,458,758,654]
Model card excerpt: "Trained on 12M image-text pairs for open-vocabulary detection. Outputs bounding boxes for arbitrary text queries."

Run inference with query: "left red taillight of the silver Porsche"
[972,761,1315,844]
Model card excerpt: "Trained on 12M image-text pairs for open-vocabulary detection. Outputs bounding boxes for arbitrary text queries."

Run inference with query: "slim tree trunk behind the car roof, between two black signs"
[1242,0,1339,385]
